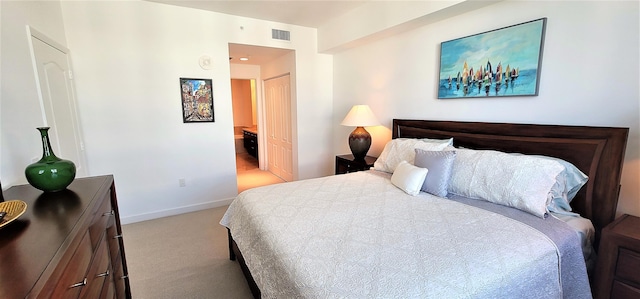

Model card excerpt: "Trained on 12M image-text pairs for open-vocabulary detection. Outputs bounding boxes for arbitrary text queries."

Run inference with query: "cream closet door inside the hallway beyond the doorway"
[264,75,293,182]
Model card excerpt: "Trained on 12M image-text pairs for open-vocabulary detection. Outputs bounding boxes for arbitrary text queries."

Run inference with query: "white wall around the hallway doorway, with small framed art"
[55,1,332,222]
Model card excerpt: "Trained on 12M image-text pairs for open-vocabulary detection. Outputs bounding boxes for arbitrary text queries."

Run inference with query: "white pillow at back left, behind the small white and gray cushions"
[373,138,453,173]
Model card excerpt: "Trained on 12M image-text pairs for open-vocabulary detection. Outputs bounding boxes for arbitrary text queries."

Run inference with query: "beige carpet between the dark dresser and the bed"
[122,206,253,299]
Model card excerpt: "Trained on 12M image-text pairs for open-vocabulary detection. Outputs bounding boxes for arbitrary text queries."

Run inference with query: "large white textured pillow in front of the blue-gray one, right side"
[449,149,564,218]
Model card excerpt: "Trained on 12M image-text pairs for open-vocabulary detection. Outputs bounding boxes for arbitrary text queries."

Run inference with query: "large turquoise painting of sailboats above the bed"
[438,18,547,99]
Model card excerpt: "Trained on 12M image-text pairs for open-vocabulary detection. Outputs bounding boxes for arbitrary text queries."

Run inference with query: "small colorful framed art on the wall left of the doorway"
[180,78,214,123]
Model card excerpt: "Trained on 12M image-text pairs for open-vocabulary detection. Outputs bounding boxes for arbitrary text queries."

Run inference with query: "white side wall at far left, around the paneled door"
[0,1,66,189]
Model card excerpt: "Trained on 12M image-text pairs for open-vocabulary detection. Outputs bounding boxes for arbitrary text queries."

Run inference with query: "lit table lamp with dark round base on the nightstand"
[340,105,380,160]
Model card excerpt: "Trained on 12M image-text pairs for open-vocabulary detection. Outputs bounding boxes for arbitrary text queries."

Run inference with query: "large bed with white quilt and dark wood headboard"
[221,119,628,298]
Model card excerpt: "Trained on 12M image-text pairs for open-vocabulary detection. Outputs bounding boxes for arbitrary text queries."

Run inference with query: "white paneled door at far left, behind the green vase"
[29,28,88,177]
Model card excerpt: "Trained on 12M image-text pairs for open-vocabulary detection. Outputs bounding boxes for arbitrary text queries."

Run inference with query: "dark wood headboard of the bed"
[392,119,629,249]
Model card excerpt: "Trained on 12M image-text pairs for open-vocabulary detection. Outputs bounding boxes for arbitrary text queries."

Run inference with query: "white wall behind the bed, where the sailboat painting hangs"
[333,1,640,216]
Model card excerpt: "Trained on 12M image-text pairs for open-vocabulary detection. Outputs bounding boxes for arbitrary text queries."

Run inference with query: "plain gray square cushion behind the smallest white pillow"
[414,148,456,197]
